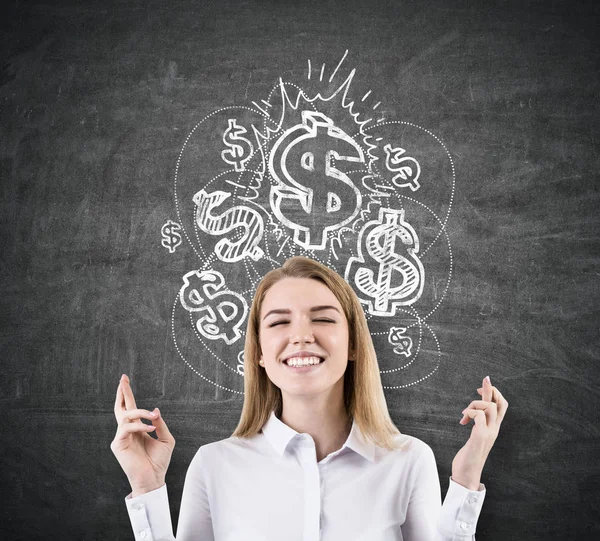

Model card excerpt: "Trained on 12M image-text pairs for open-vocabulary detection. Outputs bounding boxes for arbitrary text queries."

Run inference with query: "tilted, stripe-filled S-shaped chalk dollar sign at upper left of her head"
[193,190,264,263]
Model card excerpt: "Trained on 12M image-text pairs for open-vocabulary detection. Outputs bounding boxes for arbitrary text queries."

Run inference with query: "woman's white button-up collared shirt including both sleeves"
[125,412,486,541]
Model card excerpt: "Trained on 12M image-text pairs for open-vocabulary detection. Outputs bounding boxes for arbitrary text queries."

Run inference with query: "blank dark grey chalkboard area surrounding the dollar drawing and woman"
[0,0,600,541]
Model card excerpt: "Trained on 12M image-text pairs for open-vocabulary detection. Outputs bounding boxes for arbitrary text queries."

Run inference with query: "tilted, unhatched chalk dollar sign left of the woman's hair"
[179,270,248,344]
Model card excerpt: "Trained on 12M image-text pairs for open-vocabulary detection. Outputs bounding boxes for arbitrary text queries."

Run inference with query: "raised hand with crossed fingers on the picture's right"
[452,377,508,490]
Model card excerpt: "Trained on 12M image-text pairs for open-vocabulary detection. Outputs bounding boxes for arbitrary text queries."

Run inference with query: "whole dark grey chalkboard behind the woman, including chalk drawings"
[0,0,600,541]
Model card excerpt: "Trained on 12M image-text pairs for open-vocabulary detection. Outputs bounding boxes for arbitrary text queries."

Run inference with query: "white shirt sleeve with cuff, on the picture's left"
[125,449,214,541]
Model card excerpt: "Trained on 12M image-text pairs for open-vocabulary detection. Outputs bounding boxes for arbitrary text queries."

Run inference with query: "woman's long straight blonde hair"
[232,256,401,449]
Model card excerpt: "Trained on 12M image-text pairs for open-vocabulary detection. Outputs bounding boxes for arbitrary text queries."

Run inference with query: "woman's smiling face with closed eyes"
[259,278,349,395]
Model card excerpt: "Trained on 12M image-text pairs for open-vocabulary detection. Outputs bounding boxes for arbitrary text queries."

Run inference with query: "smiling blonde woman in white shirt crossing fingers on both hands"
[111,257,508,541]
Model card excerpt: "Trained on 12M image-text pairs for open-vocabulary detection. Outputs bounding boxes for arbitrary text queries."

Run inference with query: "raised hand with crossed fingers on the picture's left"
[110,374,175,497]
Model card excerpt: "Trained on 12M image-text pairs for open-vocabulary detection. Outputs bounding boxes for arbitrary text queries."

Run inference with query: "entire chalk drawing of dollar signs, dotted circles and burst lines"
[161,51,456,394]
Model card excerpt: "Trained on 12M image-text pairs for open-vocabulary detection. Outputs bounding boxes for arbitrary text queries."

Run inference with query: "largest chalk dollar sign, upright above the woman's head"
[269,111,364,250]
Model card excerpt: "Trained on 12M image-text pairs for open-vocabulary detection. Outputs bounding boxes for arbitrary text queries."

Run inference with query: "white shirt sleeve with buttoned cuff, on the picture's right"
[401,445,486,541]
